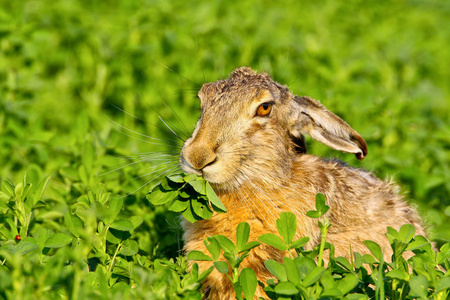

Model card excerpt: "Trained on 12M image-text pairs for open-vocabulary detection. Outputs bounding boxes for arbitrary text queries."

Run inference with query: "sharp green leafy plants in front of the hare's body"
[187,194,450,299]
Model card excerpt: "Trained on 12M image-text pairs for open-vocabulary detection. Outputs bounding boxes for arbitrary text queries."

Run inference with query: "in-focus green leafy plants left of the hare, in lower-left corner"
[0,176,207,299]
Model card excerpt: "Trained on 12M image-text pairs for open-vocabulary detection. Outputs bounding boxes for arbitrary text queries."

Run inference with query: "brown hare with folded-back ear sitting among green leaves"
[180,67,425,299]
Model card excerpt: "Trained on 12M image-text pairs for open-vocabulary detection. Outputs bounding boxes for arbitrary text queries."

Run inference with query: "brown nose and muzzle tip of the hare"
[182,143,217,172]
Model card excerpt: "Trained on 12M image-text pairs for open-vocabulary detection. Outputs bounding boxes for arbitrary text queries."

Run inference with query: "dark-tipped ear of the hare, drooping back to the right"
[289,96,367,159]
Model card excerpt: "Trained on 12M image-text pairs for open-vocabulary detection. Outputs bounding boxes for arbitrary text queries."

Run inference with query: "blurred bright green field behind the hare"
[0,0,450,255]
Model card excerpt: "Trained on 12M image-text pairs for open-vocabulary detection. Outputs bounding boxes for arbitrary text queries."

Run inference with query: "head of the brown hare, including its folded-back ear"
[180,67,367,190]
